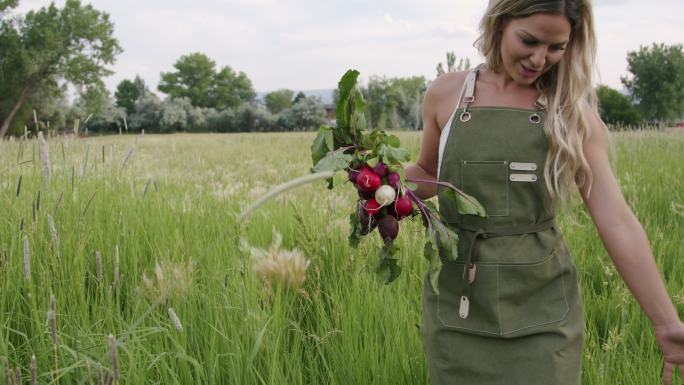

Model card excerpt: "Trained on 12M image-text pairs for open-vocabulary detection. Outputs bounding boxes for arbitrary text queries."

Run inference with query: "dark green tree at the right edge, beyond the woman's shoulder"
[621,43,684,121]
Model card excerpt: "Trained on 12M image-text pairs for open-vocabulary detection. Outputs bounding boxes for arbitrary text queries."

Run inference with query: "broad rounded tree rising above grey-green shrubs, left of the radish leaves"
[157,53,256,109]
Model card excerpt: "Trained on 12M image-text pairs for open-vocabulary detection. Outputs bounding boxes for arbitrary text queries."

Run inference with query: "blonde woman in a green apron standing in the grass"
[406,0,684,385]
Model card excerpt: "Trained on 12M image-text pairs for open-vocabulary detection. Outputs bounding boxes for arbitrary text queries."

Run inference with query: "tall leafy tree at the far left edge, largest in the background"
[0,0,121,137]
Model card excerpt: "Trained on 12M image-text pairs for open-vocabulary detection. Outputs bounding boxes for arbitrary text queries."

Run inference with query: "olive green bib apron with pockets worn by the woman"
[421,67,585,385]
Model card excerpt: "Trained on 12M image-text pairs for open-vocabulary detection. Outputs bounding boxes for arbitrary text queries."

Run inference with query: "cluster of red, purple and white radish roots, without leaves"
[348,162,413,243]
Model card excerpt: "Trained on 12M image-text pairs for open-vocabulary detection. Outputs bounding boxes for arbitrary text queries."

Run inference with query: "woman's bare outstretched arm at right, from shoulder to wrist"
[580,108,680,327]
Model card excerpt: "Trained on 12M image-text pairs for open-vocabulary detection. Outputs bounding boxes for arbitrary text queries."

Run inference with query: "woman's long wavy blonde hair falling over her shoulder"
[475,0,607,208]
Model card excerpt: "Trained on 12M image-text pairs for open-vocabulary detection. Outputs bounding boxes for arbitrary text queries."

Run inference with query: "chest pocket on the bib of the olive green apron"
[461,160,510,217]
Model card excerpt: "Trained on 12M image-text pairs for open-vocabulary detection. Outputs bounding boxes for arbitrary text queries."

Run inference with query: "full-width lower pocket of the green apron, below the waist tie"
[435,250,571,337]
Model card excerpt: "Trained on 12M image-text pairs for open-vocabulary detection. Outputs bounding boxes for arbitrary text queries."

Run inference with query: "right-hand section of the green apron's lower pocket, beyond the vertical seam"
[498,250,571,335]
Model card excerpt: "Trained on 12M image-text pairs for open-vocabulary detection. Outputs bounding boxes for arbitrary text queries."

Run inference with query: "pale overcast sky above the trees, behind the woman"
[10,0,684,92]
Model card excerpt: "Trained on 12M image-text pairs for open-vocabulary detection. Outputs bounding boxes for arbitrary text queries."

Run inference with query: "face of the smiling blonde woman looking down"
[501,13,571,85]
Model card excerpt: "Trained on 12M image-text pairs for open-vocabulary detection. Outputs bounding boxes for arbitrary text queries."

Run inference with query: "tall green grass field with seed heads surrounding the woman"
[0,132,684,385]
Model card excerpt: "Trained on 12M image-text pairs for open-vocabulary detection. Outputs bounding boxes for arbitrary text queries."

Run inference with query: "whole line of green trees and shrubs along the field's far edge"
[0,0,684,138]
